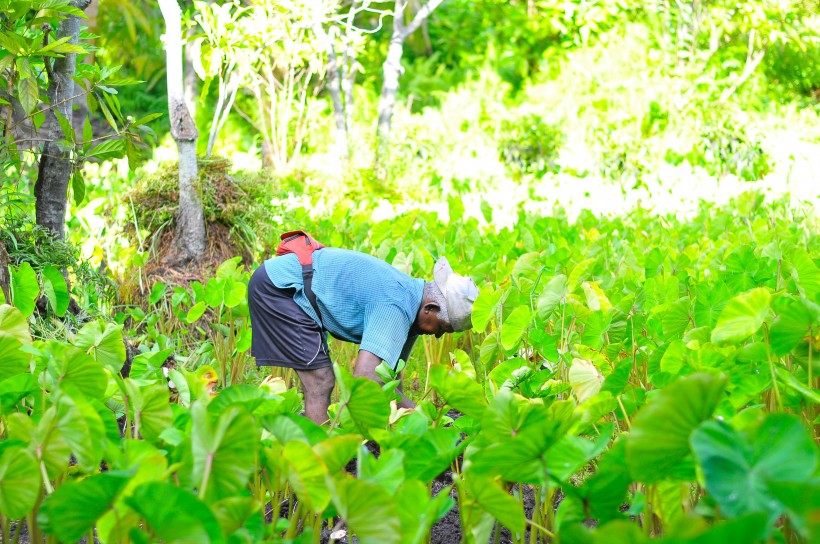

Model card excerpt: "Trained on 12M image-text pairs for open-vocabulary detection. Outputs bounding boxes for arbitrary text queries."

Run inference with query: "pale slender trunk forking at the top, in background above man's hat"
[373,0,444,178]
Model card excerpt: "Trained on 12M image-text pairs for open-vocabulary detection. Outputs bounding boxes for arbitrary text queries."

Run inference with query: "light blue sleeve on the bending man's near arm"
[359,304,415,368]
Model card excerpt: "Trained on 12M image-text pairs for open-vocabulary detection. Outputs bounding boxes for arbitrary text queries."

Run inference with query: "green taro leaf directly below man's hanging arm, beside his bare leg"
[333,364,390,436]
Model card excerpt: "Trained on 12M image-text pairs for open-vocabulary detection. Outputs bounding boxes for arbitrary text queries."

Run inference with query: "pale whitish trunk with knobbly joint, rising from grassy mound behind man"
[159,0,205,266]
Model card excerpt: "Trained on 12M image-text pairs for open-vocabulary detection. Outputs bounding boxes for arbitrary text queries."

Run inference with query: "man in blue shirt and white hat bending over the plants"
[248,238,478,424]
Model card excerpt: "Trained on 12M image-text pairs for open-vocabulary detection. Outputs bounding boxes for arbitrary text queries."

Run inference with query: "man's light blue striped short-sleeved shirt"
[265,247,425,368]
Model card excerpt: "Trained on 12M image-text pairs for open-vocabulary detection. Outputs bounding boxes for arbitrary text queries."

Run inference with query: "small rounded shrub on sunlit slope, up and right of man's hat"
[498,113,564,177]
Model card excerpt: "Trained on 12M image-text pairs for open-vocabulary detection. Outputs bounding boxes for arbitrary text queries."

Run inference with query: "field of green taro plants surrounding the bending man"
[0,193,820,544]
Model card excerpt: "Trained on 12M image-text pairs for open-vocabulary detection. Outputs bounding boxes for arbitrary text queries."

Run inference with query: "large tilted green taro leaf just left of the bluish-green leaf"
[626,374,725,483]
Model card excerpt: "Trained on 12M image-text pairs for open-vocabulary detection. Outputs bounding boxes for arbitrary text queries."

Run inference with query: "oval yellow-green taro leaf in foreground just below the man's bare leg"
[282,441,330,513]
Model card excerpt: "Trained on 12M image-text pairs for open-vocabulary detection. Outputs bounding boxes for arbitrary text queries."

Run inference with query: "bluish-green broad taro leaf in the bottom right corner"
[692,413,818,521]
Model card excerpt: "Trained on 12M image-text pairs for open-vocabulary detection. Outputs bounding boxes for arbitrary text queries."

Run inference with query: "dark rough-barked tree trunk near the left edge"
[34,0,90,239]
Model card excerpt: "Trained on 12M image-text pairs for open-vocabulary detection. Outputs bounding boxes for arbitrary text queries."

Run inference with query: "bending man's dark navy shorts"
[248,264,333,370]
